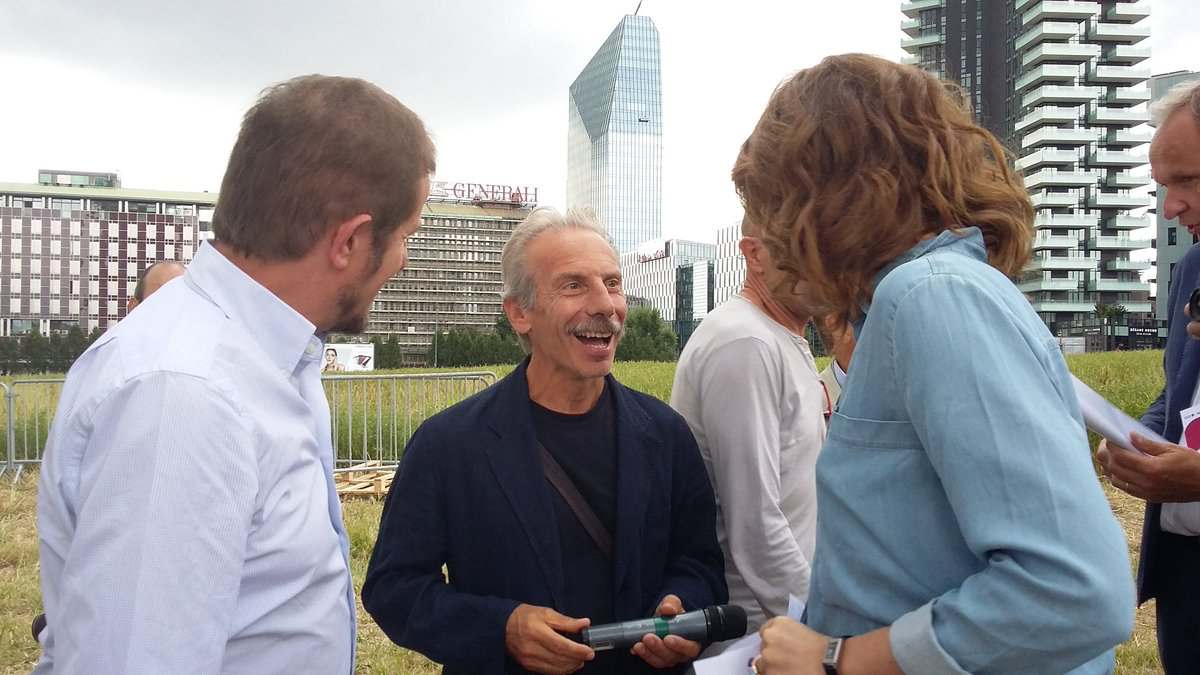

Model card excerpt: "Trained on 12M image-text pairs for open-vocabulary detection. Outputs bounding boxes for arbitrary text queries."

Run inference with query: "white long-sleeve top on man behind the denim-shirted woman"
[671,295,826,631]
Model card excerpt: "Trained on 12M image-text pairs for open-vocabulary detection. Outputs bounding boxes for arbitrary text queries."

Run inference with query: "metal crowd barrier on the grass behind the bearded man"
[0,371,496,480]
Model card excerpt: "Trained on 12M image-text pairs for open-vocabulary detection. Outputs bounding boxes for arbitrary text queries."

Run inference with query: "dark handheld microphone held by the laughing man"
[572,604,746,651]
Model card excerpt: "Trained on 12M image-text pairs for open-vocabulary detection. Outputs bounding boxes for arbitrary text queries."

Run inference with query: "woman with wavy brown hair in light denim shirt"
[733,54,1134,675]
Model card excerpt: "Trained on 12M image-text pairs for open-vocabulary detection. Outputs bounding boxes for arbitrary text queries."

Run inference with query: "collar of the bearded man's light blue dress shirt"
[184,241,323,374]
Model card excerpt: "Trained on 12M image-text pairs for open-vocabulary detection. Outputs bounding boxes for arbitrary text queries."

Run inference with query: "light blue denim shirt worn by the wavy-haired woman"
[808,227,1134,674]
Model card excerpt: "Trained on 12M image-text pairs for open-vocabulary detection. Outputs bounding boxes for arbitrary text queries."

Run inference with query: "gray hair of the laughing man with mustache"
[500,207,620,354]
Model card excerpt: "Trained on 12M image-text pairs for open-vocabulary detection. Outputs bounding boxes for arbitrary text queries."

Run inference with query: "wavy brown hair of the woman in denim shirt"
[733,54,1033,322]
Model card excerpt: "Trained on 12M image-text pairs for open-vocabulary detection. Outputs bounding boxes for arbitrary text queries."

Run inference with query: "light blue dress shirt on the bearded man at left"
[35,244,355,675]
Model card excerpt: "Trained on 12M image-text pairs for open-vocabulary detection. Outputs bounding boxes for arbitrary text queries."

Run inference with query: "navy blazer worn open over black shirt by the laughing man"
[362,360,727,674]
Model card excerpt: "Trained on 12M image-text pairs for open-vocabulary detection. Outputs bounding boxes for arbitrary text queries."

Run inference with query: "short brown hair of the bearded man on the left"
[212,74,436,261]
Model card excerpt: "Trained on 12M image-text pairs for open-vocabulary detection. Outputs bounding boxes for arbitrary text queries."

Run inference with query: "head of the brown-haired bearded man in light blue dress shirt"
[212,74,436,333]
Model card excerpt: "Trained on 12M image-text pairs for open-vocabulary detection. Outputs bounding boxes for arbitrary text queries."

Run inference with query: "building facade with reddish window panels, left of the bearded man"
[0,171,216,336]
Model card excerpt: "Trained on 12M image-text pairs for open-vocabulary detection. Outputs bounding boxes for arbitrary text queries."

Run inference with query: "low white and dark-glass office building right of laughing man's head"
[620,239,716,350]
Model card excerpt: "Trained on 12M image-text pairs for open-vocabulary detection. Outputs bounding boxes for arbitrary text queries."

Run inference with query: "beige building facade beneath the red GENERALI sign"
[367,189,536,365]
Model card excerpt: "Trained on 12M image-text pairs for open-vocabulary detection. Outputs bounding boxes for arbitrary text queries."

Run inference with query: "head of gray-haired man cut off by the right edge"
[1150,82,1200,339]
